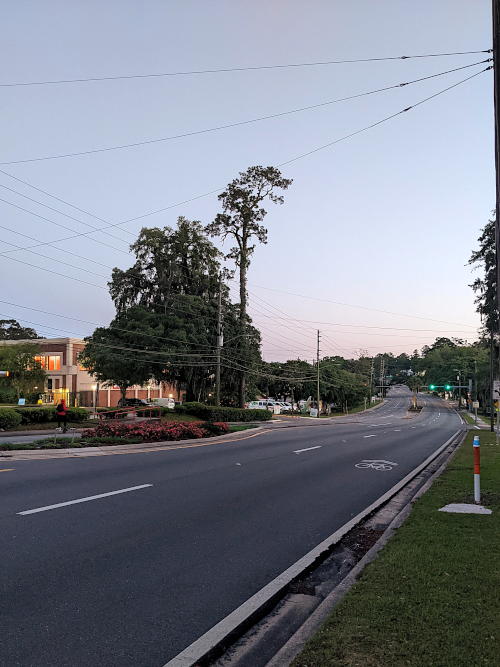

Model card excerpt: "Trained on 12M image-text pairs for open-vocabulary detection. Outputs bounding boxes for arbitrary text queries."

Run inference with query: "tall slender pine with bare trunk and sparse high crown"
[205,166,292,407]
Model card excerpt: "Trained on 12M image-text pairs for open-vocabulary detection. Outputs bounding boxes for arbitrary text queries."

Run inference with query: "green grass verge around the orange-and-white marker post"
[292,431,500,667]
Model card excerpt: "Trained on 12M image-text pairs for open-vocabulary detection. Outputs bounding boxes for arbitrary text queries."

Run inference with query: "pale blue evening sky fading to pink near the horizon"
[0,0,495,361]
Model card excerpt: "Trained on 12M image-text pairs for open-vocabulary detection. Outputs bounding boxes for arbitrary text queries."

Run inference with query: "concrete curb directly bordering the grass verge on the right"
[266,431,467,667]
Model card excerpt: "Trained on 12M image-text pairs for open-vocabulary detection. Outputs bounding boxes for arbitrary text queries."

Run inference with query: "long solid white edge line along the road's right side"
[163,429,461,667]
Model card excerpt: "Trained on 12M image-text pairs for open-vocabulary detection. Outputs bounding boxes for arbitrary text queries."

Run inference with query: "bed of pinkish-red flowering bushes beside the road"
[82,421,229,442]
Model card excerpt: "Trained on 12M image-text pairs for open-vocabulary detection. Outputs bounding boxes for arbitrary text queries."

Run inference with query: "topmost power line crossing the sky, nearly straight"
[0,49,491,88]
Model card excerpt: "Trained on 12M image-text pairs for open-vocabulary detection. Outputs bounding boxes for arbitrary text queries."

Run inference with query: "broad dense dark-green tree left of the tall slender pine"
[86,217,266,404]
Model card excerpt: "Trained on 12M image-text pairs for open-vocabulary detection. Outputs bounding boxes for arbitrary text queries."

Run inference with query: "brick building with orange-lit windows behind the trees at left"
[3,338,183,407]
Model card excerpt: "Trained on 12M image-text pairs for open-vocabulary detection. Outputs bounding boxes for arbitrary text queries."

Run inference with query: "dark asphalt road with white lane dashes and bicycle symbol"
[0,389,461,667]
